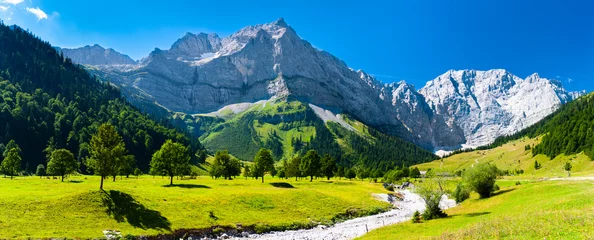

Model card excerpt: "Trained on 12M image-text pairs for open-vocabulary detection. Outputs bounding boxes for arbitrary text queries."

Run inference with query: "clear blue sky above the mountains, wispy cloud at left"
[0,0,594,91]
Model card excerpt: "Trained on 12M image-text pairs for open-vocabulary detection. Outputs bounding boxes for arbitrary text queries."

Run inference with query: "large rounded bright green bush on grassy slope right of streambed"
[464,163,499,198]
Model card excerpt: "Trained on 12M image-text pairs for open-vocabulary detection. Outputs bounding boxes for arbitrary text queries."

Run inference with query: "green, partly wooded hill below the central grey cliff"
[196,100,436,171]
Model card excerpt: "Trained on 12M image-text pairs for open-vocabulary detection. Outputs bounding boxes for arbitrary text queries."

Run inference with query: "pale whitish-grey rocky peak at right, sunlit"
[419,69,580,146]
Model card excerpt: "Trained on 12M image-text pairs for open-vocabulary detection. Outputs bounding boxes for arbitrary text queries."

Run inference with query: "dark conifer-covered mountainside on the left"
[0,24,200,172]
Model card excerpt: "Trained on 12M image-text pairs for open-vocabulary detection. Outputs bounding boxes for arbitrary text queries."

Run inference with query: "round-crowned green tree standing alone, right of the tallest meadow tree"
[150,140,190,185]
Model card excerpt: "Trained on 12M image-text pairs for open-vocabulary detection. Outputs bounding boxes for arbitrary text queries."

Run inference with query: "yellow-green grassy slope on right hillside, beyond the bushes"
[415,138,594,178]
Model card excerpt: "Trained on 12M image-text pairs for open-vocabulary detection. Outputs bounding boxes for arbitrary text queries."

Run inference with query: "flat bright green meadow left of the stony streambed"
[0,176,389,239]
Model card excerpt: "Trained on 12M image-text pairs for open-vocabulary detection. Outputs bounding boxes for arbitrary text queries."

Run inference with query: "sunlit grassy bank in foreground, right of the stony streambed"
[360,181,594,239]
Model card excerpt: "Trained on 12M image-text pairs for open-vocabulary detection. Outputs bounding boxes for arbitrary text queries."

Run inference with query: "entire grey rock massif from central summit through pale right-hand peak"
[65,19,579,150]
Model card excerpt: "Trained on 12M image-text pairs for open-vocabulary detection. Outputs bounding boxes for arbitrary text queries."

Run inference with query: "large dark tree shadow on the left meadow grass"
[101,190,171,231]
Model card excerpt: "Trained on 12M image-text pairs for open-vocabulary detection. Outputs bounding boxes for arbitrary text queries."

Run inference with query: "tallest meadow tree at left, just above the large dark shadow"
[86,123,127,190]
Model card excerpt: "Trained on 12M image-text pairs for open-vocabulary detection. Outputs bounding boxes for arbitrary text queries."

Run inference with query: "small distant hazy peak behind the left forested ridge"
[56,44,136,65]
